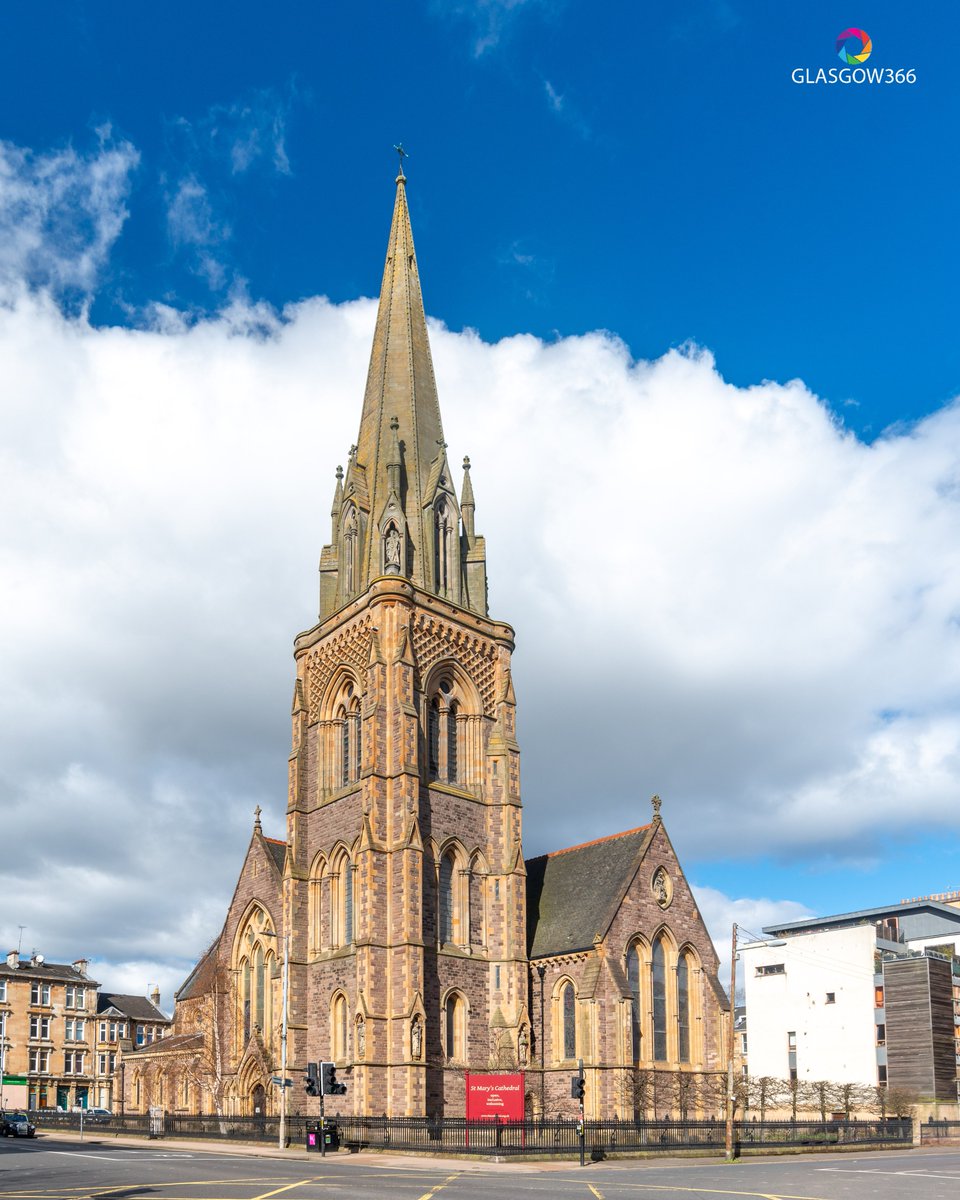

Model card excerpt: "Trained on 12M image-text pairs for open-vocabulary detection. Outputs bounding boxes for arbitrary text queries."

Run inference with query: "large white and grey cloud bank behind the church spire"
[0,131,960,994]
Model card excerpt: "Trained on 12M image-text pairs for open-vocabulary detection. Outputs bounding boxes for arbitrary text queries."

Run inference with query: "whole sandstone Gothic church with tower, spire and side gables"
[125,174,727,1116]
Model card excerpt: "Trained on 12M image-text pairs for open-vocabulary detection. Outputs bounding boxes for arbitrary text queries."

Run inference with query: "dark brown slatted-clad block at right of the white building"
[883,958,956,1100]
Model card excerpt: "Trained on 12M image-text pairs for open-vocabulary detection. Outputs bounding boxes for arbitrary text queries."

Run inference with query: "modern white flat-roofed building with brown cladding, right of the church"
[739,896,960,1102]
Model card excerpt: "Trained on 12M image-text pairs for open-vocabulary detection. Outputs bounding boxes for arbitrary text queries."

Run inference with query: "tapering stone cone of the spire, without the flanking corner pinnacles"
[355,173,444,586]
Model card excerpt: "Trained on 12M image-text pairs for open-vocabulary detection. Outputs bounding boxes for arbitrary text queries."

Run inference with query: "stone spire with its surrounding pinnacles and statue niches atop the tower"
[320,169,486,618]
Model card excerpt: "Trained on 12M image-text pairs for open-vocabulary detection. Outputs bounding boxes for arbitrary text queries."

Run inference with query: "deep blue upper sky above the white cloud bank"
[0,0,945,436]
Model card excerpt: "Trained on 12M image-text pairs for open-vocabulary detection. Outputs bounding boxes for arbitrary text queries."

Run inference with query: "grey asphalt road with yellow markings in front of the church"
[0,1135,960,1200]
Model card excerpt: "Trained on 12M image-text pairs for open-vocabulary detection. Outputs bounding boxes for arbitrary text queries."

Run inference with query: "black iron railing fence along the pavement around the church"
[34,1111,912,1159]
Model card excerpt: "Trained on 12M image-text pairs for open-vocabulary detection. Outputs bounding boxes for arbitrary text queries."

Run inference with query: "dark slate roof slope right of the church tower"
[527,824,654,959]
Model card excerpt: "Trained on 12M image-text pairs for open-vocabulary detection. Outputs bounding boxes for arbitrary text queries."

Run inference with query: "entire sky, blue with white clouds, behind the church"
[0,0,960,986]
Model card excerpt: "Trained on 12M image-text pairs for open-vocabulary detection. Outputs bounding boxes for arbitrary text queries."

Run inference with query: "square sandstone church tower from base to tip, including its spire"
[284,170,529,1115]
